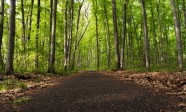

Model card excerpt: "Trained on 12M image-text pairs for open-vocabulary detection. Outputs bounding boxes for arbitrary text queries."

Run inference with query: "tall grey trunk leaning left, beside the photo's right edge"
[170,0,183,71]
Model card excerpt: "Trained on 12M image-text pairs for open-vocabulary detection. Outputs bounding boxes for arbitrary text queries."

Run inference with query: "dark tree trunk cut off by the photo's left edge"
[0,0,4,68]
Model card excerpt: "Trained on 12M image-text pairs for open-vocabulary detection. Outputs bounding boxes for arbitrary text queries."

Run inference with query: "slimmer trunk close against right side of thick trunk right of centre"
[120,0,127,69]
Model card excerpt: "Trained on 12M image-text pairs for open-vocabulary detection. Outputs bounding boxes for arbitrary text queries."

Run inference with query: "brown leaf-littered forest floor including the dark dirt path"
[0,71,186,112]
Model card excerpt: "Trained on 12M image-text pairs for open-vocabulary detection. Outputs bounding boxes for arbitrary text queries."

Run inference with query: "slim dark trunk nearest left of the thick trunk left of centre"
[35,0,41,70]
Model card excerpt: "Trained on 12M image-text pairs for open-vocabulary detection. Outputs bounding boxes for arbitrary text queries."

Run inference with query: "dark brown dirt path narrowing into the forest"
[13,72,184,112]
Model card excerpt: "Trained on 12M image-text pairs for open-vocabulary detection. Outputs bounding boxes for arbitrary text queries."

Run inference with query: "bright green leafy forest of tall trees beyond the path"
[0,0,186,74]
